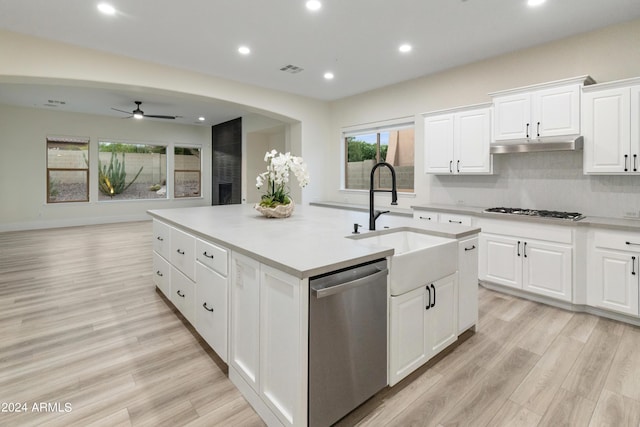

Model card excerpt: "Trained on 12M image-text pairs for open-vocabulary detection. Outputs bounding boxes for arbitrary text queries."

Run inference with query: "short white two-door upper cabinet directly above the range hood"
[490,76,593,141]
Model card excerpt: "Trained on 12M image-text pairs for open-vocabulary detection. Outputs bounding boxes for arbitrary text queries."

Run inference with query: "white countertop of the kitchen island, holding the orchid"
[148,205,480,278]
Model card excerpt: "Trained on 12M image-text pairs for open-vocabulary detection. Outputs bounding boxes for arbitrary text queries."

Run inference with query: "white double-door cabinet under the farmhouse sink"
[389,273,458,386]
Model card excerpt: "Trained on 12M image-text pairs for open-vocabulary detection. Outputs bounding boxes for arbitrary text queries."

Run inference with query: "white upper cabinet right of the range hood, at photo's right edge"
[582,79,640,175]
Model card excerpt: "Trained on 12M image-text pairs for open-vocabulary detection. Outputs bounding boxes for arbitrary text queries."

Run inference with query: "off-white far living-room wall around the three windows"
[0,105,211,231]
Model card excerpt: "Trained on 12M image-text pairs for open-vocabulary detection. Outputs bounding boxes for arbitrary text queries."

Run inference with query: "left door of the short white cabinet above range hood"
[493,93,531,141]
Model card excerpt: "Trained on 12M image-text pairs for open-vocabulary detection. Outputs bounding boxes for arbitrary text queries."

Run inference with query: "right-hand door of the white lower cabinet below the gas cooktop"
[522,240,572,302]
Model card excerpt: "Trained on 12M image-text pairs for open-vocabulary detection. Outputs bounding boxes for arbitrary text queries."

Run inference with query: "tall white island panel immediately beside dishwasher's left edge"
[259,264,308,426]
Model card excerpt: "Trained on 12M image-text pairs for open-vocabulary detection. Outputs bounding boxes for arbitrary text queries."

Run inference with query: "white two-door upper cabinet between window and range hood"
[424,105,493,175]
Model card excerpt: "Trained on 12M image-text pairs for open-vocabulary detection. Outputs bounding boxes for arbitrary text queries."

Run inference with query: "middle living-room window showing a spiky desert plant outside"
[98,141,167,201]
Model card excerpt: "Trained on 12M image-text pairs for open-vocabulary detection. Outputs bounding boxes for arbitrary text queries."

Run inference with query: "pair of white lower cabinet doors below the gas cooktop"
[478,233,573,302]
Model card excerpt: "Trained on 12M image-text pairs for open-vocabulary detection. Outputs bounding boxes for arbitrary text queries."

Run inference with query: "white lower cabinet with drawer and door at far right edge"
[587,230,640,316]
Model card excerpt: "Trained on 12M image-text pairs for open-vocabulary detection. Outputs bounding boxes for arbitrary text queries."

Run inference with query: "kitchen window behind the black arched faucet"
[344,125,415,192]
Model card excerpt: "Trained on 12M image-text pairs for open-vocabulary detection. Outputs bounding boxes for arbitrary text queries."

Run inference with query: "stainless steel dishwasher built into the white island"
[309,259,388,427]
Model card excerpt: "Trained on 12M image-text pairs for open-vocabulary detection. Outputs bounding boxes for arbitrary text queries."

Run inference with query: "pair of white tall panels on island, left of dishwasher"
[229,253,308,426]
